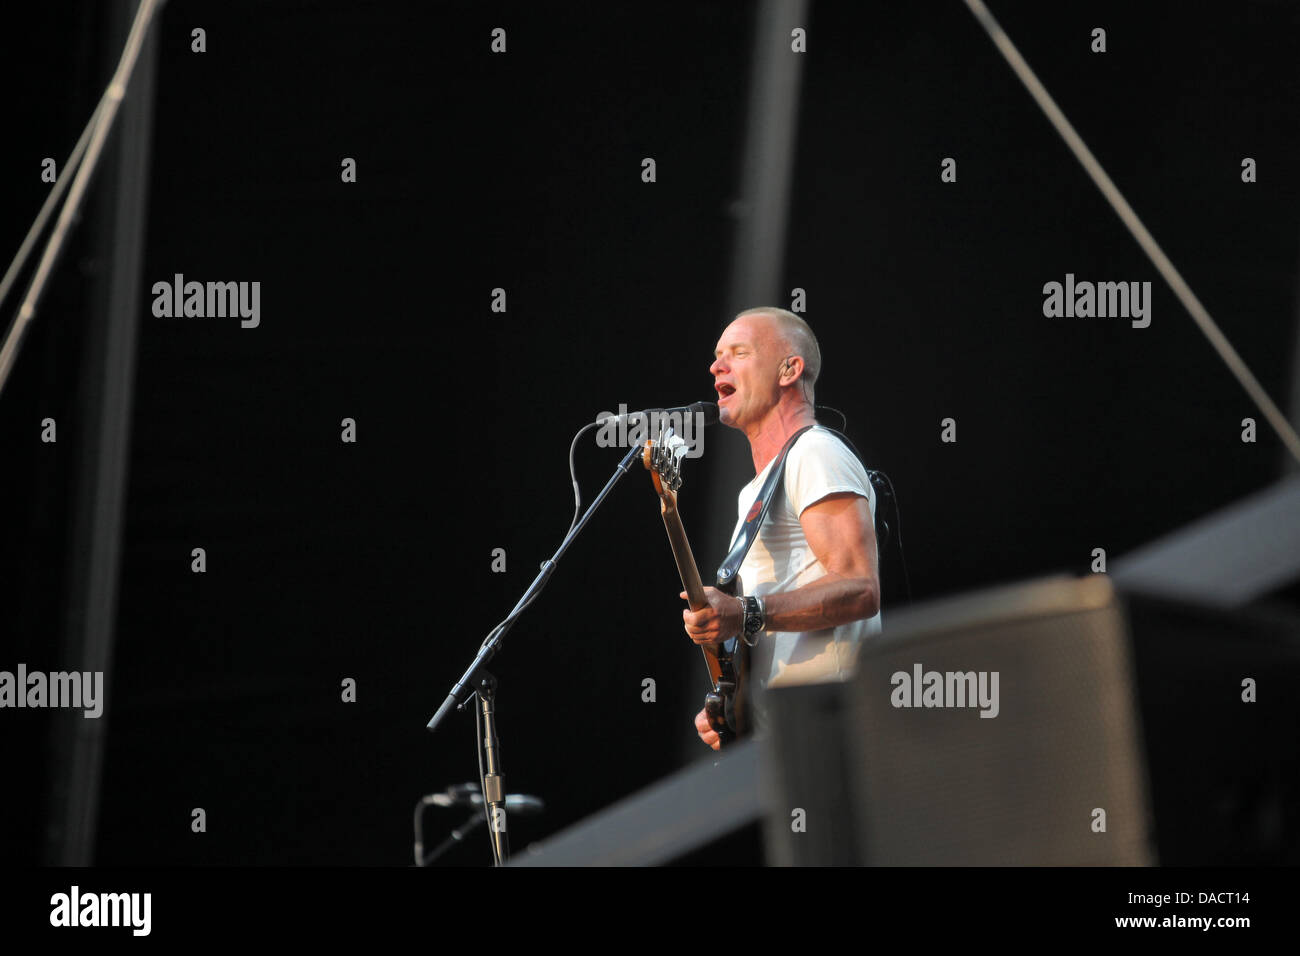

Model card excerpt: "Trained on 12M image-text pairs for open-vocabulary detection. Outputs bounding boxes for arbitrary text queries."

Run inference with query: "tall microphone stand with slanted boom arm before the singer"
[426,444,645,866]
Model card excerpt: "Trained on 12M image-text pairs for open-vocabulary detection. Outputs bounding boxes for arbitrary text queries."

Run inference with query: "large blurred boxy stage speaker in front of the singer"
[762,575,1156,866]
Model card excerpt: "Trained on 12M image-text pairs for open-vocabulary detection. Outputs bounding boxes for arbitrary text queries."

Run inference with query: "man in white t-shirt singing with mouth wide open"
[681,308,880,750]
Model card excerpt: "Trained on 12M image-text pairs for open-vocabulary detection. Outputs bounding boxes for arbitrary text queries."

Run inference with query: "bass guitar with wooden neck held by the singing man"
[641,429,749,747]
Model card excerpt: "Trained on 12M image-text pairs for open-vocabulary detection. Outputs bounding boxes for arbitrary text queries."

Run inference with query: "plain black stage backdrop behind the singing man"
[0,3,1300,864]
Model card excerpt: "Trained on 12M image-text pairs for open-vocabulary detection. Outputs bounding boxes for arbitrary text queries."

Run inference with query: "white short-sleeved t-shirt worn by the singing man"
[732,427,880,688]
